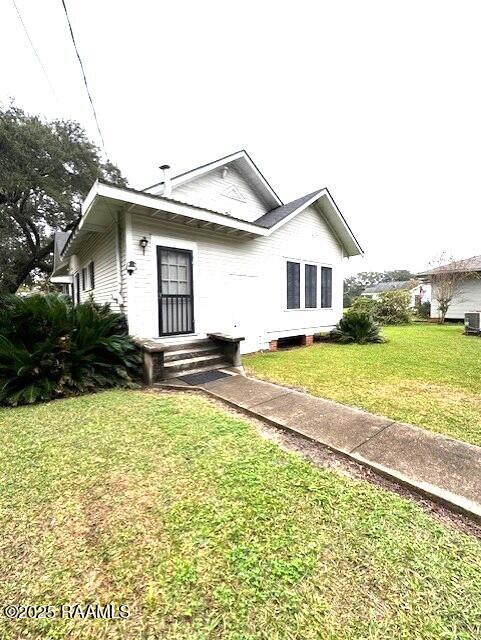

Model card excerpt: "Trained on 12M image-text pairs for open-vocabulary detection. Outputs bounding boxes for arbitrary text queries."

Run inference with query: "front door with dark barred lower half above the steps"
[157,247,194,336]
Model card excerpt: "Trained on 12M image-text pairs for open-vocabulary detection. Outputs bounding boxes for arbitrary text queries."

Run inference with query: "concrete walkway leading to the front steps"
[190,375,481,521]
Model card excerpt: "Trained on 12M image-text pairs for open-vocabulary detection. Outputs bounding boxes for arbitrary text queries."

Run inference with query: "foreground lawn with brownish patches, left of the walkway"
[0,388,481,640]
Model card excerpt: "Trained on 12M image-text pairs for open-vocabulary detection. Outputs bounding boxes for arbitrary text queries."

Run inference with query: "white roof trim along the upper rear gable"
[143,149,282,207]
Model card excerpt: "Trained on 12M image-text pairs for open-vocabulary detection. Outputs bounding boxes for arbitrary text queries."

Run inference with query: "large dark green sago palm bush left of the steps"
[0,294,140,406]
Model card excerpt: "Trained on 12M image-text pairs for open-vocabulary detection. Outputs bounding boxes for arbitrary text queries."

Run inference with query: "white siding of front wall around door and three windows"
[128,207,343,353]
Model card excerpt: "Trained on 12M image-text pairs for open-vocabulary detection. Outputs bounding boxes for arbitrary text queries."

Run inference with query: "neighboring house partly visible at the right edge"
[418,256,481,321]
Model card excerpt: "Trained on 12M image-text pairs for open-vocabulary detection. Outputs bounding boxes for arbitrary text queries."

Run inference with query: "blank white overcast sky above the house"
[0,0,481,271]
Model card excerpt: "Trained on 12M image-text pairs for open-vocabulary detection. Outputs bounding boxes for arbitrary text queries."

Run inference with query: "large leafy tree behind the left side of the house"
[0,104,126,293]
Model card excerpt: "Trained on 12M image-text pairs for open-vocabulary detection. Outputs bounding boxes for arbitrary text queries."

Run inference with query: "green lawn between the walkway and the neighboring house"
[244,324,481,445]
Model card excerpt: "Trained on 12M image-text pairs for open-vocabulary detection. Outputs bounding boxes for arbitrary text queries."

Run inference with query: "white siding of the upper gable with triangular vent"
[152,166,269,222]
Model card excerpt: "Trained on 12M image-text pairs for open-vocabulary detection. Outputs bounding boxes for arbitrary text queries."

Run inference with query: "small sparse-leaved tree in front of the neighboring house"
[424,253,479,324]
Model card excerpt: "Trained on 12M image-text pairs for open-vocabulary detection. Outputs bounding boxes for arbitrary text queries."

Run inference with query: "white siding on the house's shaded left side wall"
[70,226,119,311]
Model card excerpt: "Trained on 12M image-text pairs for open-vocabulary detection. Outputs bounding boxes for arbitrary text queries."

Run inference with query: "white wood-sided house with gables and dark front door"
[53,151,362,380]
